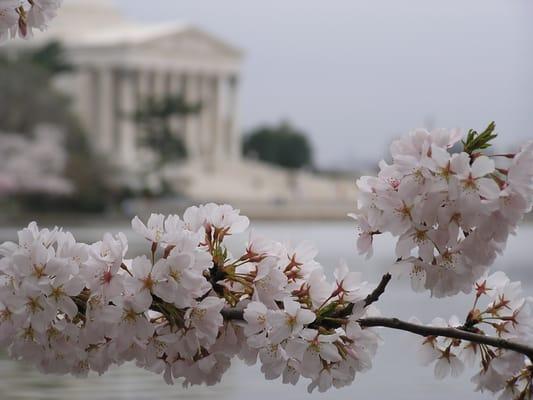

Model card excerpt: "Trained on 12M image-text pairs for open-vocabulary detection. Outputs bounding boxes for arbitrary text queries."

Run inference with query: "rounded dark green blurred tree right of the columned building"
[243,122,313,169]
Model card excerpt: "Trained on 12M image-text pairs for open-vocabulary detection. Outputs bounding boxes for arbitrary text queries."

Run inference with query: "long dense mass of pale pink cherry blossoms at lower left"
[0,203,379,391]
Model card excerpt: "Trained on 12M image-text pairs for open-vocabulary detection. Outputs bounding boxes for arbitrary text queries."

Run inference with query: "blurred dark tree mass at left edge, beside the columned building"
[0,43,109,211]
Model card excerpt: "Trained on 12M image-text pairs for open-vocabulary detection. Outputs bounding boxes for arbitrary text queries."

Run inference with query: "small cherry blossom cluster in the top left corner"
[0,0,62,42]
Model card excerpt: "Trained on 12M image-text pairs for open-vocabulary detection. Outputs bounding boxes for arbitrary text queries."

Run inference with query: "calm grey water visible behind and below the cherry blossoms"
[0,222,533,400]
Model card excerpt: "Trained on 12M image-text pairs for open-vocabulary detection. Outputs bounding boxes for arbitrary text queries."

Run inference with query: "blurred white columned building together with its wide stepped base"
[9,0,355,218]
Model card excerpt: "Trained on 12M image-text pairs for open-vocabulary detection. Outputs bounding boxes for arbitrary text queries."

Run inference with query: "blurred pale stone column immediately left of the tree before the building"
[119,71,137,169]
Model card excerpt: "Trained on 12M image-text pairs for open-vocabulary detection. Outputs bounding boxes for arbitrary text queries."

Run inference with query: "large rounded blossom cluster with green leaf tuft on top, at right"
[351,124,533,297]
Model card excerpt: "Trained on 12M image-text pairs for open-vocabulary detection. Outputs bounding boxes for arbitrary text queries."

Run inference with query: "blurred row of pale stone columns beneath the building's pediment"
[77,67,240,168]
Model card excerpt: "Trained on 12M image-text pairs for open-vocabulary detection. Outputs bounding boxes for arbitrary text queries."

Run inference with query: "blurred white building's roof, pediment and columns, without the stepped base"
[14,0,242,170]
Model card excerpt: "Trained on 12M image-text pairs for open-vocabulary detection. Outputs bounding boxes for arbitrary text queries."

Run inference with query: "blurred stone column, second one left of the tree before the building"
[97,67,117,155]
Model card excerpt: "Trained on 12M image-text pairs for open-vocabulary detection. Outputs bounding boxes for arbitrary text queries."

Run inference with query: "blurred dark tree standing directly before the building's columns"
[133,94,201,164]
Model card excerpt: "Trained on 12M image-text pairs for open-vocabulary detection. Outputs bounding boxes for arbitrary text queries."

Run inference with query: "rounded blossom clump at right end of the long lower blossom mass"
[244,257,379,392]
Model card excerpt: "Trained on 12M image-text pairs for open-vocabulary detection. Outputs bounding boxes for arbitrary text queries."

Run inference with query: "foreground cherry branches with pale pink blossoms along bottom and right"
[0,124,533,400]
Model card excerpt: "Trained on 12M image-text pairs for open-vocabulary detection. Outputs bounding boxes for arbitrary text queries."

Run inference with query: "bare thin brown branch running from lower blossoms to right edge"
[358,317,533,361]
